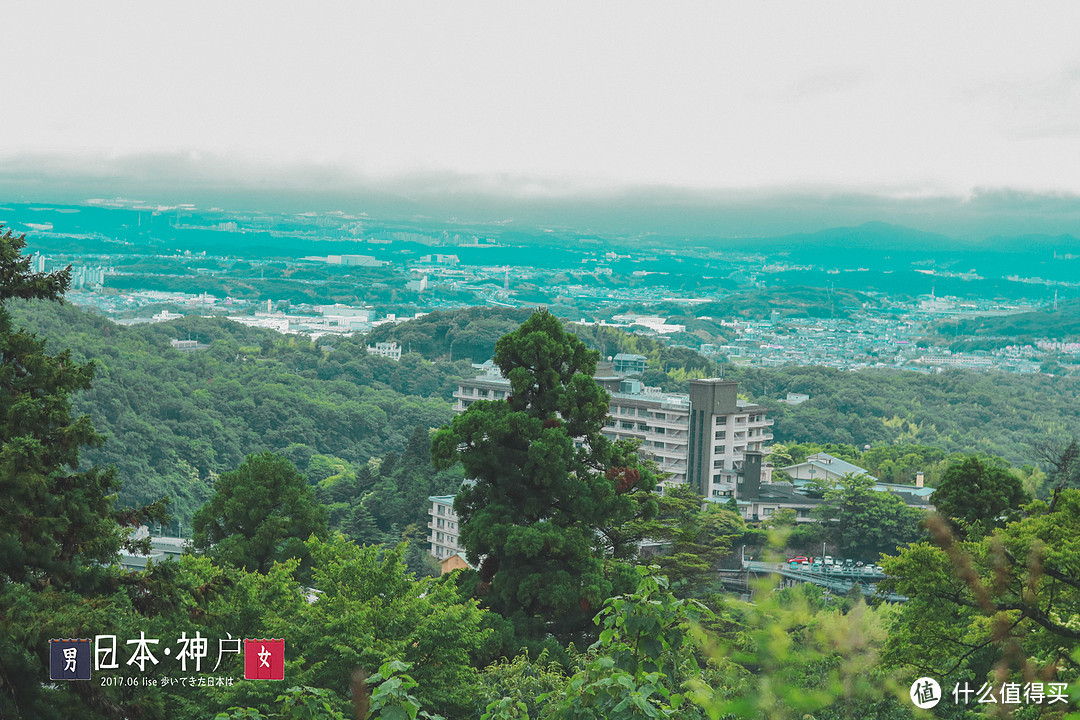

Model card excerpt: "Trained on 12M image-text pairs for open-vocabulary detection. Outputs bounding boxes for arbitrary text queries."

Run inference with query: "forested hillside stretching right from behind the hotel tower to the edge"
[728,367,1080,464]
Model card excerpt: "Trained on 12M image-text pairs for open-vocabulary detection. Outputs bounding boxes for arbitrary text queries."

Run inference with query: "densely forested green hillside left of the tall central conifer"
[12,303,470,522]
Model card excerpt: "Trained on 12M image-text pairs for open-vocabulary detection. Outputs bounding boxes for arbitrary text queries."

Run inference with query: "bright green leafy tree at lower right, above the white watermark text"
[883,489,1080,681]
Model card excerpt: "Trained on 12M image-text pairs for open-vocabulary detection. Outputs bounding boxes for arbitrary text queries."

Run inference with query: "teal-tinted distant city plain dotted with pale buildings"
[8,201,1080,375]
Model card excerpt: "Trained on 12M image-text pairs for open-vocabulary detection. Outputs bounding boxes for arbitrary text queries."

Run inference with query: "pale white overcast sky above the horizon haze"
[0,0,1080,196]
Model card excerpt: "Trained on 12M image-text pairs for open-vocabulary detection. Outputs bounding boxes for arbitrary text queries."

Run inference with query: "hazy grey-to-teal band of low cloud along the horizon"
[0,154,1080,241]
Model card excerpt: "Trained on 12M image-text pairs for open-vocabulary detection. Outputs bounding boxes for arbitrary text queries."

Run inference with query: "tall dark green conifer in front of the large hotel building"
[432,310,657,642]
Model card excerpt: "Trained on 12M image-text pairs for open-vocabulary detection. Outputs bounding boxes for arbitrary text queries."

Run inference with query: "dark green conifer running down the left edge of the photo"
[0,226,165,718]
